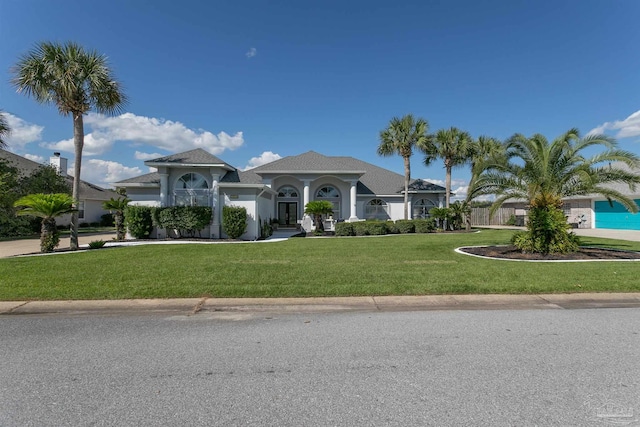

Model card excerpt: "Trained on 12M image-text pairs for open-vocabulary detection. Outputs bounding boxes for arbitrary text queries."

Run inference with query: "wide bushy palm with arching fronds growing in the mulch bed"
[473,129,640,253]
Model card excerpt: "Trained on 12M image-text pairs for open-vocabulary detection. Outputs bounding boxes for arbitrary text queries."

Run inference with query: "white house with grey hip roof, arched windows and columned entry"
[114,149,445,240]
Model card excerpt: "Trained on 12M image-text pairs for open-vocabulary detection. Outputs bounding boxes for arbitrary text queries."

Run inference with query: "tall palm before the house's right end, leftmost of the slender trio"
[378,114,429,219]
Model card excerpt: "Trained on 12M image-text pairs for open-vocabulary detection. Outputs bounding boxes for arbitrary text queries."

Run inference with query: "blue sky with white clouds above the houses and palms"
[0,0,640,194]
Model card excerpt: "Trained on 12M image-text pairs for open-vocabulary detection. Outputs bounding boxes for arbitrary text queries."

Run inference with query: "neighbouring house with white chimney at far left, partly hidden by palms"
[0,150,118,225]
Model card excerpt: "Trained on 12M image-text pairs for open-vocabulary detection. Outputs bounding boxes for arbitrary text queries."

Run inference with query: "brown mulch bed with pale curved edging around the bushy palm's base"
[460,245,640,261]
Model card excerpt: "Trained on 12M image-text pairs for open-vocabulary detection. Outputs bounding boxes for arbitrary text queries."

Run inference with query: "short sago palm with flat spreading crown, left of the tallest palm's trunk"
[14,193,74,252]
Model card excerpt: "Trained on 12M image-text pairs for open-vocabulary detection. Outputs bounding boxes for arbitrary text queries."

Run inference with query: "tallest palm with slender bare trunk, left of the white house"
[12,42,126,250]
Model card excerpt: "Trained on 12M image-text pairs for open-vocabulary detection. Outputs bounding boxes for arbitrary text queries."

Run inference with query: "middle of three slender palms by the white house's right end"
[424,127,472,208]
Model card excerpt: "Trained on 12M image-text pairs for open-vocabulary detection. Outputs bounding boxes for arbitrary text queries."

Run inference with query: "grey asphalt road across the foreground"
[0,308,640,426]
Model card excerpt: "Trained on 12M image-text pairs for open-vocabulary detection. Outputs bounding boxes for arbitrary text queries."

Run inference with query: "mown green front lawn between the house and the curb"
[0,230,640,300]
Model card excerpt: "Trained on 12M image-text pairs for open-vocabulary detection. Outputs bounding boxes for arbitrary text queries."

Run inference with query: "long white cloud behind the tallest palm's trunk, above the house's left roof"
[45,113,244,156]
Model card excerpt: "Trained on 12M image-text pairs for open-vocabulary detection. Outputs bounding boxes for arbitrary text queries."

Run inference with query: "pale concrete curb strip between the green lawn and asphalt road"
[0,293,640,317]
